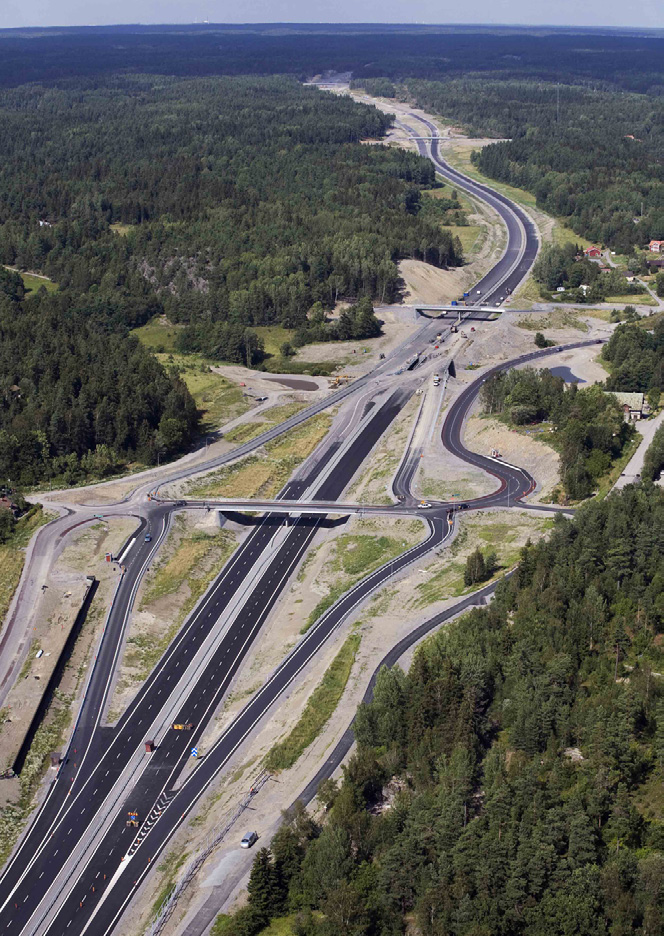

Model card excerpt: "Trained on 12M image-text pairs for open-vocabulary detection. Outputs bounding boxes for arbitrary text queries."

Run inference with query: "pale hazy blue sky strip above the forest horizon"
[0,0,664,28]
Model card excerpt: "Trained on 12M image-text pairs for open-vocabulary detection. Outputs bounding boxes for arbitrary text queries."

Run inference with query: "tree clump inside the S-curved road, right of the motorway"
[480,368,634,500]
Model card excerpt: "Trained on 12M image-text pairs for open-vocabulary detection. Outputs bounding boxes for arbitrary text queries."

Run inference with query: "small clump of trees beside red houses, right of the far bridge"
[533,243,646,302]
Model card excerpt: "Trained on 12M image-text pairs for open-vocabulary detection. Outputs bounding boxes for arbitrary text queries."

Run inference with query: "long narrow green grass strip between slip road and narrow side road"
[265,634,361,770]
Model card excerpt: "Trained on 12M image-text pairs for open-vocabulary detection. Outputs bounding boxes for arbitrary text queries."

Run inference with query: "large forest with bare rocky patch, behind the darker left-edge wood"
[0,76,463,336]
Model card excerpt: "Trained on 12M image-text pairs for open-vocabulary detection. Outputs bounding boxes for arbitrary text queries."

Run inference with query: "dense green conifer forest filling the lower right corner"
[220,485,664,936]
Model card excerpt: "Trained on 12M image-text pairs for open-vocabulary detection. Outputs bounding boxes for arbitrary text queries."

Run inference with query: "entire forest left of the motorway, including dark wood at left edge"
[0,76,462,485]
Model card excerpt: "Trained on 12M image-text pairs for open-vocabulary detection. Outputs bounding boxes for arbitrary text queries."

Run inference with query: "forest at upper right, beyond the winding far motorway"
[394,77,664,252]
